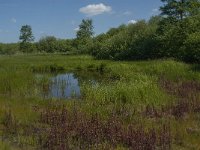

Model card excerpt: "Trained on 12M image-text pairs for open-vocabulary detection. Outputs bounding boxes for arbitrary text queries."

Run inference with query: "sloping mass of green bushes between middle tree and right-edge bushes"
[92,21,157,60]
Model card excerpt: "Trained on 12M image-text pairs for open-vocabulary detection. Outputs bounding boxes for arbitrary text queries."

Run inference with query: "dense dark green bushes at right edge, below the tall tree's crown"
[155,12,200,62]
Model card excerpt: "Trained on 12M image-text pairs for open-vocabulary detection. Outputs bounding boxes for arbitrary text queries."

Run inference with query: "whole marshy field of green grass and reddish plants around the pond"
[0,55,200,150]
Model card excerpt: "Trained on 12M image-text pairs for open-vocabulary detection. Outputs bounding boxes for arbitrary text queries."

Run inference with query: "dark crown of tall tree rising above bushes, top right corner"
[160,0,200,20]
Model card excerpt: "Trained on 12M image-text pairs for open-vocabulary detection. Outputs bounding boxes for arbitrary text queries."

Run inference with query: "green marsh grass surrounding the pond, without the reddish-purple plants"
[0,55,200,150]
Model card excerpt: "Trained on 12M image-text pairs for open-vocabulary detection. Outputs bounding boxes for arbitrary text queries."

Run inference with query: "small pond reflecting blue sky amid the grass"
[37,73,99,99]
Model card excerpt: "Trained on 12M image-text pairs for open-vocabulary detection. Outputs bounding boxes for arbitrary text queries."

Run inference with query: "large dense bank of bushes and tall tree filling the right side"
[92,0,200,63]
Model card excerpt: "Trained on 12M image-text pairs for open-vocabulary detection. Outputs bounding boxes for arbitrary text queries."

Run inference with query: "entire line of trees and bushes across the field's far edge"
[0,0,200,63]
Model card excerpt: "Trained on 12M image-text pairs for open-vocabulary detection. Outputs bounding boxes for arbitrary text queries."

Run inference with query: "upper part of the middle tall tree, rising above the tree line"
[76,19,94,39]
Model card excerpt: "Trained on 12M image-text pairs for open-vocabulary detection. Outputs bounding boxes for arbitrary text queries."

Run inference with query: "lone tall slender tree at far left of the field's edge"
[19,25,34,52]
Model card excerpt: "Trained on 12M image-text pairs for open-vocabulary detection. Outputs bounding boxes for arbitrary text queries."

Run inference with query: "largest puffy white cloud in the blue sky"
[79,3,112,16]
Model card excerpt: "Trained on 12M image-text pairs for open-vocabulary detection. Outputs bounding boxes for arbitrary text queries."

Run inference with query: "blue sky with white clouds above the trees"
[0,0,162,43]
